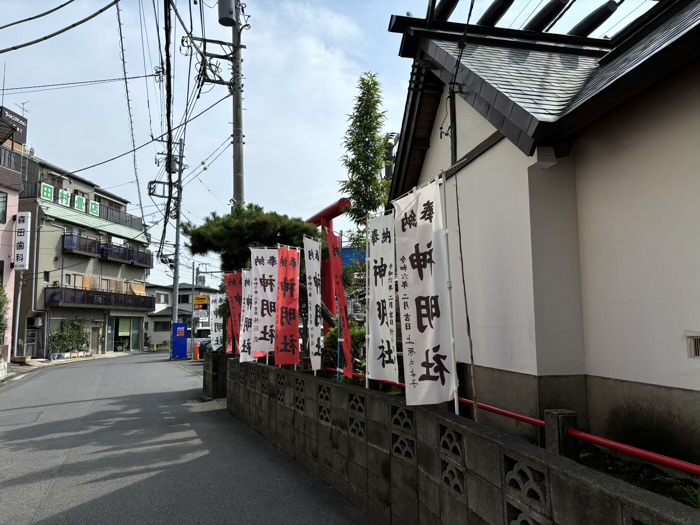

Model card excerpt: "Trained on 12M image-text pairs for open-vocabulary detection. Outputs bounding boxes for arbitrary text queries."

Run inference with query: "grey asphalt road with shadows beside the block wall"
[0,354,378,525]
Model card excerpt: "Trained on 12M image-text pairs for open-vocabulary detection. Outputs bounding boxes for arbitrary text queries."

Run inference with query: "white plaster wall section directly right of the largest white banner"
[446,139,537,374]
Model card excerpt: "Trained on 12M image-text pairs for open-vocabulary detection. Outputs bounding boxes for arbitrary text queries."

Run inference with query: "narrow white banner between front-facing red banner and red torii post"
[304,237,323,370]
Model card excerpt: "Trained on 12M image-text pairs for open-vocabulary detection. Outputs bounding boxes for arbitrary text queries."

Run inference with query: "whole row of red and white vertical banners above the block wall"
[225,179,457,405]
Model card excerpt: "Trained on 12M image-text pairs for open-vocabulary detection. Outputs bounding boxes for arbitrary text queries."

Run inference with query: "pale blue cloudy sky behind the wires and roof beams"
[0,0,653,283]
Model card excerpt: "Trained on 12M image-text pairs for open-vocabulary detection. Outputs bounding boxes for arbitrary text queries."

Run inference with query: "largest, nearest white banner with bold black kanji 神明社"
[394,181,457,405]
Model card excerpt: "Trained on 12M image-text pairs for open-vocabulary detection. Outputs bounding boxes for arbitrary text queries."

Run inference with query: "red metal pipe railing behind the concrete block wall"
[326,368,700,476]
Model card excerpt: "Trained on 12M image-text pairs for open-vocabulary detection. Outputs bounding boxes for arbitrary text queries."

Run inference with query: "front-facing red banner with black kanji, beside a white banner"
[275,248,301,365]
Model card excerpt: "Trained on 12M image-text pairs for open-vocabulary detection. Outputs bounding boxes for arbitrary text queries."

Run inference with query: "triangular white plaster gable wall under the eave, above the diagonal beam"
[419,89,496,184]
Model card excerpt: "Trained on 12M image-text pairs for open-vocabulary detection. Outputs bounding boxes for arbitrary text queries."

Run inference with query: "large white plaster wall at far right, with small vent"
[573,66,700,390]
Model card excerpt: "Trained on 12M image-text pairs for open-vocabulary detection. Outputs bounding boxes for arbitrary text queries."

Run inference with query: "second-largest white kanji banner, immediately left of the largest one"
[367,212,399,383]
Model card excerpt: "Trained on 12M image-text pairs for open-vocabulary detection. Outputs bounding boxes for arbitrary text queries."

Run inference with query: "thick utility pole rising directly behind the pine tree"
[231,0,244,212]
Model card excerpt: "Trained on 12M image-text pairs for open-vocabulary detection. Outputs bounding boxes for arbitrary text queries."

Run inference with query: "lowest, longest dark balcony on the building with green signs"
[45,286,156,312]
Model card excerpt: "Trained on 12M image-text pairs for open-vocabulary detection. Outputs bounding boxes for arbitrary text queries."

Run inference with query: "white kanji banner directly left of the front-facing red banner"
[250,248,277,355]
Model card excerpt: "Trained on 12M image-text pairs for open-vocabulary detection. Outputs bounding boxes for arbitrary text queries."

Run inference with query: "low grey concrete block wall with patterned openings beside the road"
[227,359,700,525]
